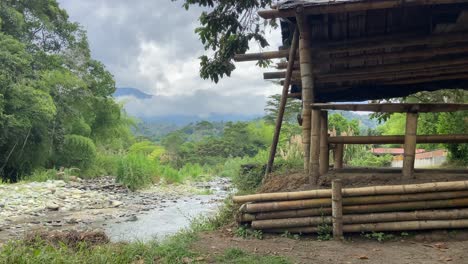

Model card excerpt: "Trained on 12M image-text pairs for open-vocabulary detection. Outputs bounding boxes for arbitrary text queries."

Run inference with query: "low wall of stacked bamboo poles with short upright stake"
[233,180,468,237]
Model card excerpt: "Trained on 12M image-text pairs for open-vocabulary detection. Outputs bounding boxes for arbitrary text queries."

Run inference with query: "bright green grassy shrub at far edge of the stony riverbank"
[117,154,158,190]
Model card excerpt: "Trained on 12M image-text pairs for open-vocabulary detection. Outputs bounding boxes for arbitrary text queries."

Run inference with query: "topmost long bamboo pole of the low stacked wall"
[233,181,468,203]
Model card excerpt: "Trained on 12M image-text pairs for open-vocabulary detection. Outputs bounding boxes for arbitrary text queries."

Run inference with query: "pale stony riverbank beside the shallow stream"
[0,177,230,243]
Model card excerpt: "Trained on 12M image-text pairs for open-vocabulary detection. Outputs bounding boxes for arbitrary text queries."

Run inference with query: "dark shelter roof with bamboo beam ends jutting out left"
[236,0,468,102]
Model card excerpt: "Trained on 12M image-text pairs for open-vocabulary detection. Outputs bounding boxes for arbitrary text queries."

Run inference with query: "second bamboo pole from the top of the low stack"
[242,191,468,213]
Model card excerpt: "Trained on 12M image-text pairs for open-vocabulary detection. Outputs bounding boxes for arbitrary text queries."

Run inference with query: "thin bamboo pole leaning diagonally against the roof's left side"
[265,28,299,174]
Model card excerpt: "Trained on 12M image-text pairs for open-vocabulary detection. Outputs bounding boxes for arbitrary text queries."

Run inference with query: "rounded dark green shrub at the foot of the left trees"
[58,135,96,171]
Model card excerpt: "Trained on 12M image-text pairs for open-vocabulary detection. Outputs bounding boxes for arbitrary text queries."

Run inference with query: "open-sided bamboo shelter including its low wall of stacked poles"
[235,0,468,237]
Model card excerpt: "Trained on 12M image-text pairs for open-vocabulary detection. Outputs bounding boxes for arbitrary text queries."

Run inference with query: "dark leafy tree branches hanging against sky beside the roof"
[177,0,276,82]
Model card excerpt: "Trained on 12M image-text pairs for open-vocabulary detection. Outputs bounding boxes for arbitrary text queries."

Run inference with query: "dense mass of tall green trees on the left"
[0,0,132,181]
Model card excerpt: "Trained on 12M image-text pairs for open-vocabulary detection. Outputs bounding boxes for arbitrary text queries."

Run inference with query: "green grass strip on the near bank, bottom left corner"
[0,231,198,264]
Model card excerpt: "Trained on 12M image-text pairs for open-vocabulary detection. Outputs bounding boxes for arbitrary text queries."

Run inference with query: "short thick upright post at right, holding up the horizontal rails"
[403,112,418,179]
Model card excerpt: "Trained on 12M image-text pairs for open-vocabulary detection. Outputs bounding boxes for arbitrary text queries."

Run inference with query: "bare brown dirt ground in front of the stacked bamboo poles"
[193,230,468,264]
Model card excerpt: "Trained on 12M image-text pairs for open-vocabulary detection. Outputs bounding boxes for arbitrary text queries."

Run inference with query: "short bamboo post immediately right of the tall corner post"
[309,110,321,186]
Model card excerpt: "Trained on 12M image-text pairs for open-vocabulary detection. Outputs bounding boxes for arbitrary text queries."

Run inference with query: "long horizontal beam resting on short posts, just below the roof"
[312,103,468,113]
